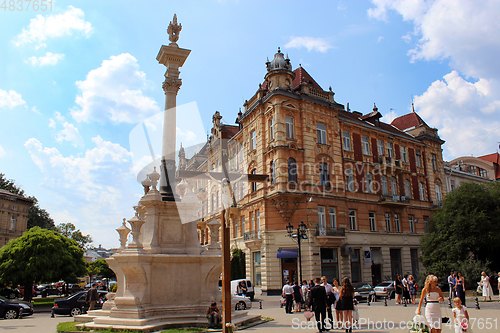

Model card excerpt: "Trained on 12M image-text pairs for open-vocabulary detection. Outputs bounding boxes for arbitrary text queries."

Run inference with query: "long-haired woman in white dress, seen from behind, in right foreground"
[415,275,444,333]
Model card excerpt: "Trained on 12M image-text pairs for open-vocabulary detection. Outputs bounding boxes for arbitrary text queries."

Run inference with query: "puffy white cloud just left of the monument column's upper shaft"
[71,53,160,123]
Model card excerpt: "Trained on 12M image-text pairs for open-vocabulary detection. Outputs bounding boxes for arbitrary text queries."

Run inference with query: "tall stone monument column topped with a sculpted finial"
[156,14,191,201]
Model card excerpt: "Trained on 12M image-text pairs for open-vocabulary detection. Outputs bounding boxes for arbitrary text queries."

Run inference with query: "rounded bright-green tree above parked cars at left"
[0,227,86,301]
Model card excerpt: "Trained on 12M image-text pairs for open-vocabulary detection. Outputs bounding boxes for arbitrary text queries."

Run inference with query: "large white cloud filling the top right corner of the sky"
[368,0,500,79]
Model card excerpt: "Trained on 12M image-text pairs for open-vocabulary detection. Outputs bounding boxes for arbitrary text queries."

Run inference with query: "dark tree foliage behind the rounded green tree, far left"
[0,173,55,230]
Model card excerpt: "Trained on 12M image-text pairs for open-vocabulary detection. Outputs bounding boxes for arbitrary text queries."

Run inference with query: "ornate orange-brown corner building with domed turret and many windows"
[179,49,446,294]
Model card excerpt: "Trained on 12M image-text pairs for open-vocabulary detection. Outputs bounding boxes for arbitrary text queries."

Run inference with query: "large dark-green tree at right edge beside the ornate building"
[421,183,500,280]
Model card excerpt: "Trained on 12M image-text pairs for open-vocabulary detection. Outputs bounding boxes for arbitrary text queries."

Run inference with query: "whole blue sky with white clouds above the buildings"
[0,0,500,247]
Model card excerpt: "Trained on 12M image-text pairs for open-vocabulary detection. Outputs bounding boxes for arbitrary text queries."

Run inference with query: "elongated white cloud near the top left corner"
[13,6,93,49]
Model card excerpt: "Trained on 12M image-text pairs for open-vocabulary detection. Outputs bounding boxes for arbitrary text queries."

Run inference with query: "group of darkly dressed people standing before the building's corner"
[282,276,355,332]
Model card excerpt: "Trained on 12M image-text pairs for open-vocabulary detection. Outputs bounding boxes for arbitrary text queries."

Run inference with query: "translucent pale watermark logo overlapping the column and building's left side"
[129,102,248,223]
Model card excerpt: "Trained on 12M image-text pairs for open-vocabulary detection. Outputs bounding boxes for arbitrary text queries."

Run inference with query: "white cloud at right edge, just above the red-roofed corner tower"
[415,71,500,160]
